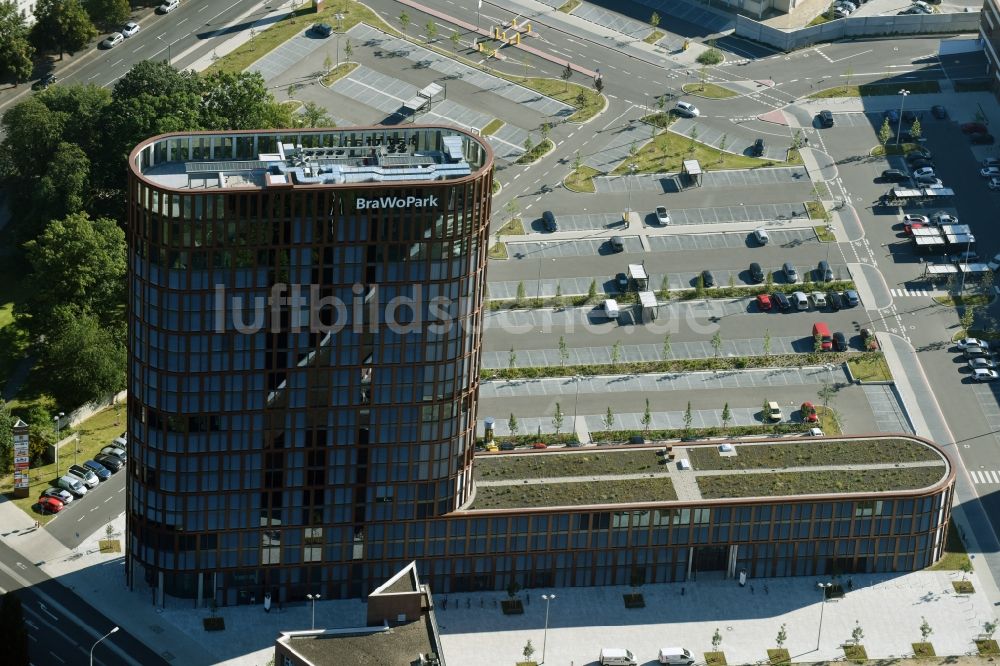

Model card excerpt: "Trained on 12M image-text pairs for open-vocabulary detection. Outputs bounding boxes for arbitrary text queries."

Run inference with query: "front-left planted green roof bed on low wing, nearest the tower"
[470,474,677,509]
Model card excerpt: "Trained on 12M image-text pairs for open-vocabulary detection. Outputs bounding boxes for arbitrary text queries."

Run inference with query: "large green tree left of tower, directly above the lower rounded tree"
[14,213,125,339]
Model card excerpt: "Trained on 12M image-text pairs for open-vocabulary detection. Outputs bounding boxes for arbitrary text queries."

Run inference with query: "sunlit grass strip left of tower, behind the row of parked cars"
[0,405,125,523]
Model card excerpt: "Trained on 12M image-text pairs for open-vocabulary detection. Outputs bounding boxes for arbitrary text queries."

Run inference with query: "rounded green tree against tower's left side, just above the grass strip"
[42,309,125,405]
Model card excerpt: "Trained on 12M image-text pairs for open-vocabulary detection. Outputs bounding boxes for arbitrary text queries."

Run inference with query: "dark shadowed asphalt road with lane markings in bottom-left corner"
[0,542,167,666]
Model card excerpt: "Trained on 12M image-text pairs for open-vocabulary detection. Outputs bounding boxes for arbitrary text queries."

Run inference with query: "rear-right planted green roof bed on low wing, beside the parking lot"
[688,439,940,471]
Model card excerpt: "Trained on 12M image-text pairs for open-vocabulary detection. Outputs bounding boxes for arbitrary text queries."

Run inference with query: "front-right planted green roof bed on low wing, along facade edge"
[697,465,945,499]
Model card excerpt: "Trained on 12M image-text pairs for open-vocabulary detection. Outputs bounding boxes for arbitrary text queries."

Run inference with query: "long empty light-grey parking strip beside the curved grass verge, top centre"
[347,23,574,117]
